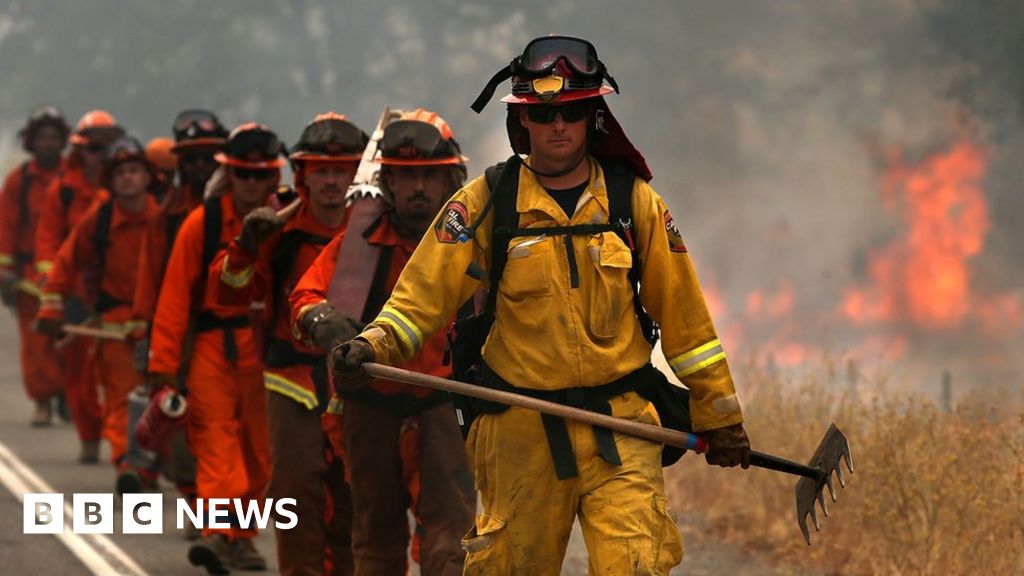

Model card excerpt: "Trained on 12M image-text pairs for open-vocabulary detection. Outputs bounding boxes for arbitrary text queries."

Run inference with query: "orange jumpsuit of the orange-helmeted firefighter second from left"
[36,156,106,442]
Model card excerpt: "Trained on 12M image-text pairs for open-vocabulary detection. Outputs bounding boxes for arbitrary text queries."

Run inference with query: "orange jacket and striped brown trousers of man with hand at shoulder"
[209,203,352,574]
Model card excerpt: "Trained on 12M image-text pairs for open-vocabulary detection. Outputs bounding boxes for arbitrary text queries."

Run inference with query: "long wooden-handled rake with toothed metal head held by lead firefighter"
[362,362,853,545]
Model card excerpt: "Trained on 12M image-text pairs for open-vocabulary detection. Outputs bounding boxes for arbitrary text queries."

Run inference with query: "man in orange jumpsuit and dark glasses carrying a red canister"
[148,123,285,574]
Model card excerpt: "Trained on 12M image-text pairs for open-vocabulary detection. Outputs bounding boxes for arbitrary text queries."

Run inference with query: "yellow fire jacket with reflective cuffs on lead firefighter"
[360,159,742,431]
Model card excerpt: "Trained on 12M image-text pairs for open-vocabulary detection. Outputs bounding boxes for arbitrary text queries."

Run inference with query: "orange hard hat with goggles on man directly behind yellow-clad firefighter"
[377,108,467,166]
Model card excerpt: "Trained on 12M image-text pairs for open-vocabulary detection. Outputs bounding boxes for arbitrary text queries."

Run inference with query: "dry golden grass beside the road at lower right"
[668,360,1024,575]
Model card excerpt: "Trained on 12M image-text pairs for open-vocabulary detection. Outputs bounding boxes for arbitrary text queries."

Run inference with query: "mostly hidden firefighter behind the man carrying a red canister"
[131,109,227,540]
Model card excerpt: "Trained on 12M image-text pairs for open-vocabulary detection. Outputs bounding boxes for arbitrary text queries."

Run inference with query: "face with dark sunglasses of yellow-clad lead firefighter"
[519,102,589,165]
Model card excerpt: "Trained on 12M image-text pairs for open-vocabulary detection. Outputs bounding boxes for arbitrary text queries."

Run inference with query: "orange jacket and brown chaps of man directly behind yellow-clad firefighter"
[290,215,476,575]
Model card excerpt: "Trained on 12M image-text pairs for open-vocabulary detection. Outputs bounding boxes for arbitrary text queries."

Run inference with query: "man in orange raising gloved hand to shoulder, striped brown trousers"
[210,112,370,575]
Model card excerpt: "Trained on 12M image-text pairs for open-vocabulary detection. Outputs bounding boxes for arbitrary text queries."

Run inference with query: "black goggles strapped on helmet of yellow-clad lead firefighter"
[470,36,618,113]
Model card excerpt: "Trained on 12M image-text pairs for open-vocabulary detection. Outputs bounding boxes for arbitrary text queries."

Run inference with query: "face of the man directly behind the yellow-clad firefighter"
[384,166,452,233]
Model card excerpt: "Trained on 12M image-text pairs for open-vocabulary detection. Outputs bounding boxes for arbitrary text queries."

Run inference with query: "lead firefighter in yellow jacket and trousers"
[332,36,750,575]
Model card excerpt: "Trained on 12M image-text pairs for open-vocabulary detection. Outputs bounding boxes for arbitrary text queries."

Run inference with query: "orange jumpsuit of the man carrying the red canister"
[150,191,269,537]
